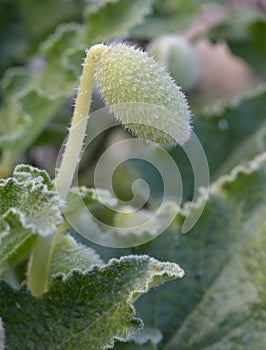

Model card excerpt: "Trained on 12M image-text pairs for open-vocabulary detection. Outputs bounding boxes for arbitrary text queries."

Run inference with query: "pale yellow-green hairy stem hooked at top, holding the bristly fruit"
[55,45,109,199]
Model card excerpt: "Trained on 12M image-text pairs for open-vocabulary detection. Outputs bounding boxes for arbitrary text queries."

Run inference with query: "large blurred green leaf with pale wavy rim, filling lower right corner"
[107,153,266,350]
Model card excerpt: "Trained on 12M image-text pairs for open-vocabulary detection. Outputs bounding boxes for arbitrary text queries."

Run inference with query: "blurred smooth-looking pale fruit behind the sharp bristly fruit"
[147,35,198,90]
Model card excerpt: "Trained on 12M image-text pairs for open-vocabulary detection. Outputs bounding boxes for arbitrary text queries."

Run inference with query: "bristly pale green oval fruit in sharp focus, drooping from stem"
[95,44,191,145]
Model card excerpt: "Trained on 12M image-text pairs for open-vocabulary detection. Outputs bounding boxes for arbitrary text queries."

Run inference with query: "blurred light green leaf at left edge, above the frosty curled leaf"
[0,69,63,168]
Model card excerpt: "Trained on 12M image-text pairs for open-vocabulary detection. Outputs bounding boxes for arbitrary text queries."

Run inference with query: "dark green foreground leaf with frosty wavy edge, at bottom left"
[0,256,183,350]
